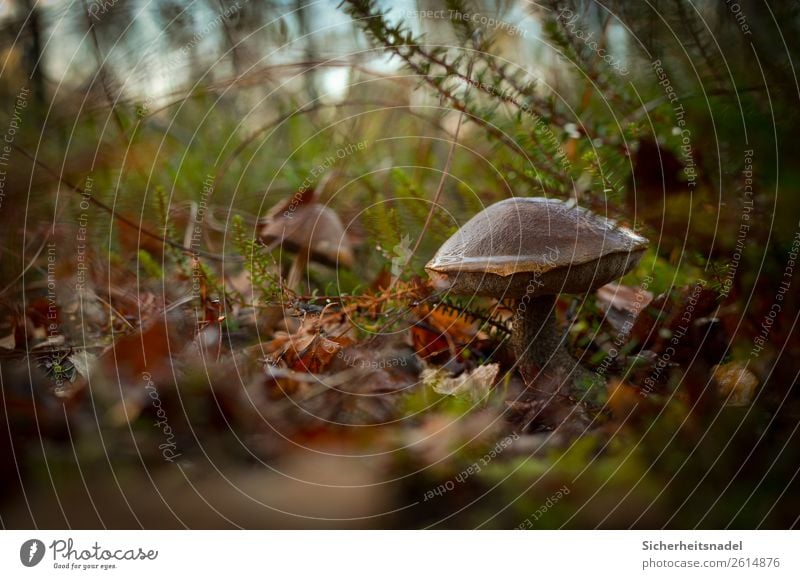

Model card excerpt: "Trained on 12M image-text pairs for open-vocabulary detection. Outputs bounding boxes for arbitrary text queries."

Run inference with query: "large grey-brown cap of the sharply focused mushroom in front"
[425,197,648,298]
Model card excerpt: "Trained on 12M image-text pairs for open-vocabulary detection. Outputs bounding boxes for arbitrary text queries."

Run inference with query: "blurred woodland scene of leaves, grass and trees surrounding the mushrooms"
[0,0,800,528]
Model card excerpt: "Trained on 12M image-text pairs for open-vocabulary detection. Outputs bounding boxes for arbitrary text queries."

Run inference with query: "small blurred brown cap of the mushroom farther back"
[259,203,354,267]
